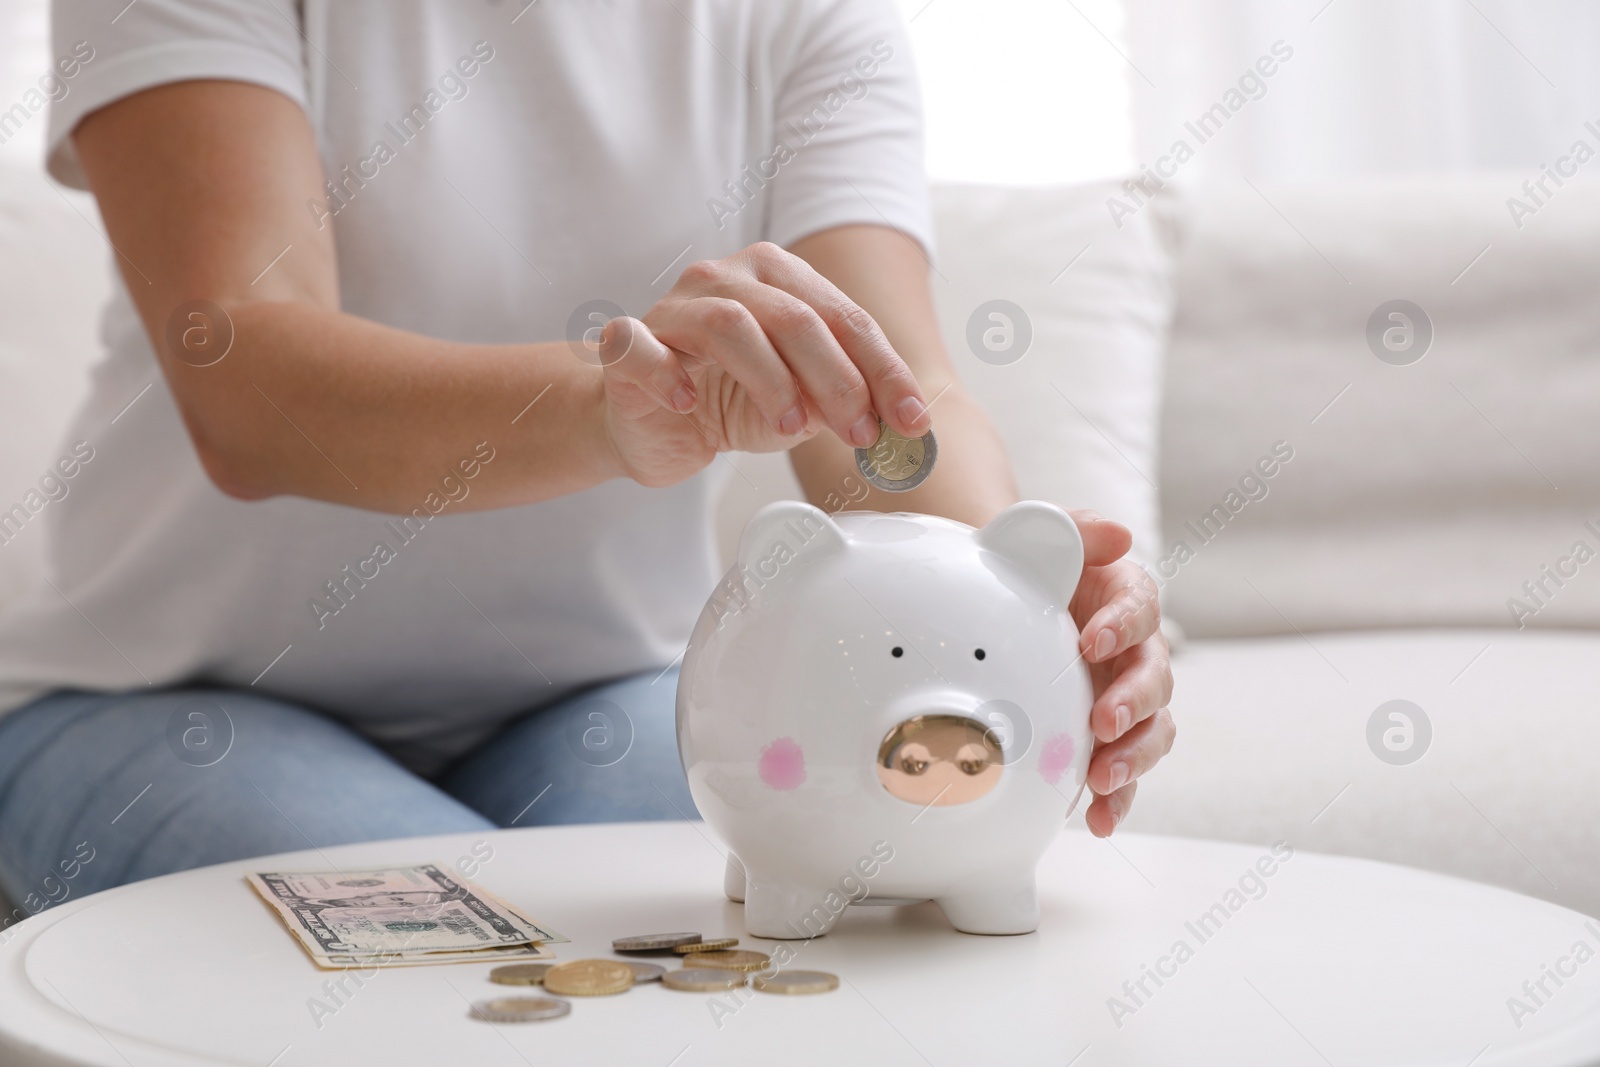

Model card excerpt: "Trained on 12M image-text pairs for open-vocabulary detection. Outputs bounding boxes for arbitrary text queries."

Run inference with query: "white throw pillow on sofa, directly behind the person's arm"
[718,181,1171,563]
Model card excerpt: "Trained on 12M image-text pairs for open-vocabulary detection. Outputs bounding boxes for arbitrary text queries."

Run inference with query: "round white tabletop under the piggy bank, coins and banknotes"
[0,822,1600,1067]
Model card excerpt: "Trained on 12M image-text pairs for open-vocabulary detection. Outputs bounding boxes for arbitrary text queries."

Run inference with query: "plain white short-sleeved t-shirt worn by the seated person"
[0,0,930,771]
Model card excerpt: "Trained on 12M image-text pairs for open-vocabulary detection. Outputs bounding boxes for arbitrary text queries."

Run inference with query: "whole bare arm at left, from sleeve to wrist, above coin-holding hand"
[74,82,621,512]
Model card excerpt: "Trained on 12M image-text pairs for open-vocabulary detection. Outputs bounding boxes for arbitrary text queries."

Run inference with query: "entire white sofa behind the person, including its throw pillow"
[0,158,1600,913]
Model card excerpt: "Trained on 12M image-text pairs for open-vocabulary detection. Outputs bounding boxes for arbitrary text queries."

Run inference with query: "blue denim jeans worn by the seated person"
[0,669,696,941]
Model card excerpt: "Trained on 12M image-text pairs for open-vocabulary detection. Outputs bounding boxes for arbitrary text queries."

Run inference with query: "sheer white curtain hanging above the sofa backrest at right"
[1125,0,1600,179]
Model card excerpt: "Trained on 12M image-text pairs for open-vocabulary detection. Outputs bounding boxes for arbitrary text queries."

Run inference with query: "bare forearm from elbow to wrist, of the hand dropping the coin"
[181,302,622,512]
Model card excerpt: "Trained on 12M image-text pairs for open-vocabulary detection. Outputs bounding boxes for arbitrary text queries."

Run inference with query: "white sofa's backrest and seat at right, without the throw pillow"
[1126,174,1600,915]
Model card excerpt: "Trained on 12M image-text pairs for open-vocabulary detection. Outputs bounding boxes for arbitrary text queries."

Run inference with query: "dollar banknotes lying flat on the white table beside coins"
[246,864,566,968]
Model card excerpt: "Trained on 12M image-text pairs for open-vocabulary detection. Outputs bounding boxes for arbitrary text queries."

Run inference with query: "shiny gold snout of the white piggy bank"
[878,715,1002,806]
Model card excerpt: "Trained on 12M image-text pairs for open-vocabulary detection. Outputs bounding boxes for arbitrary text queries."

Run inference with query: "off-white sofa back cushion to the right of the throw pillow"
[1162,173,1600,635]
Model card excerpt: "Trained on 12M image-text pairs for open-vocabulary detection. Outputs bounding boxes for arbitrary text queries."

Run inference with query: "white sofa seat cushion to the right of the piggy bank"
[1113,630,1600,915]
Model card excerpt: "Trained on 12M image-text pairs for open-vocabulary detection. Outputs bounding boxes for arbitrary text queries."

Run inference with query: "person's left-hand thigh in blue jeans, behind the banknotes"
[0,689,493,896]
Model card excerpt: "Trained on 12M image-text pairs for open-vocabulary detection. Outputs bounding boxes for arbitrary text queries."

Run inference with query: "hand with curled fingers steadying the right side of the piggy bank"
[1069,510,1178,837]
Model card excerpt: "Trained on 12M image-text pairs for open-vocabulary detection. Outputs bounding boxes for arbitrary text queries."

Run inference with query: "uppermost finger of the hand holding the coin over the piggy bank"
[733,242,928,448]
